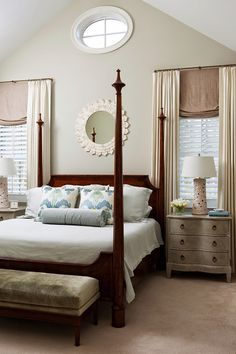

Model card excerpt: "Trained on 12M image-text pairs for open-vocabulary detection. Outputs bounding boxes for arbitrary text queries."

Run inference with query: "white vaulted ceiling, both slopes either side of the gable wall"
[0,0,236,61]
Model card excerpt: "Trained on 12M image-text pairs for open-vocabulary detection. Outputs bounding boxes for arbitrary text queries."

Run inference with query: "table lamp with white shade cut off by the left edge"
[0,157,16,208]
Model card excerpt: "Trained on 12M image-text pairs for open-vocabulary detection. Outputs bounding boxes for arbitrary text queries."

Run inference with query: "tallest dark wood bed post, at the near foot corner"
[112,70,125,327]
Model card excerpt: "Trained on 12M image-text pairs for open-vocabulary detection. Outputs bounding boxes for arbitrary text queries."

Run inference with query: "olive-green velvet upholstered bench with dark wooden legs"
[0,269,100,346]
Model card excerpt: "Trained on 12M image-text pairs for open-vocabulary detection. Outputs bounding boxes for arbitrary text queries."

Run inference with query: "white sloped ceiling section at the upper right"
[143,0,236,51]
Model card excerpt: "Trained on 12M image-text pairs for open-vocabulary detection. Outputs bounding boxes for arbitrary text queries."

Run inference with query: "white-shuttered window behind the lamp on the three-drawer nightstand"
[179,117,219,207]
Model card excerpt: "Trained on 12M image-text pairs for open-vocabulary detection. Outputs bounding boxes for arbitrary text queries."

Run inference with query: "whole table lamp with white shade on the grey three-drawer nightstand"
[182,156,216,215]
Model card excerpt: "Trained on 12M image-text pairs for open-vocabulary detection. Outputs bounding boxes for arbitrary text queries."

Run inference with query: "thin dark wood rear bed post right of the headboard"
[158,108,166,233]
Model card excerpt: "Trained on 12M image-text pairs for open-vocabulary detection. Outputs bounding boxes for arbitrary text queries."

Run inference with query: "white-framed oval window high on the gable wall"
[72,6,133,53]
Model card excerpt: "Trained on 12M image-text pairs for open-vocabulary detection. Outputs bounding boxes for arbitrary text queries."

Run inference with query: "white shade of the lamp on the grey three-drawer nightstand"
[182,156,216,178]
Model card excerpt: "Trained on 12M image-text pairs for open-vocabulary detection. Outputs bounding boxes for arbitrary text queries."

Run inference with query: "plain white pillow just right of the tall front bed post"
[123,184,152,222]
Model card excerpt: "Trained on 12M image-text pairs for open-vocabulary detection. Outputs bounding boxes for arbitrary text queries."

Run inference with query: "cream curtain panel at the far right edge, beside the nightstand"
[218,66,236,272]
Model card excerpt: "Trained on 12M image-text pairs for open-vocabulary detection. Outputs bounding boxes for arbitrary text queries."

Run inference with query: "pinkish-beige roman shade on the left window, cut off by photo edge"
[0,81,28,125]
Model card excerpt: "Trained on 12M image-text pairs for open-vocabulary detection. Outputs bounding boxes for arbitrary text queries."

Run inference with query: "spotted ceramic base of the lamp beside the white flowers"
[192,178,208,215]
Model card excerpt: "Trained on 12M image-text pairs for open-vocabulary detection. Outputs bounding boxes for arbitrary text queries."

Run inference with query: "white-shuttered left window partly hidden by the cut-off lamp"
[0,124,27,195]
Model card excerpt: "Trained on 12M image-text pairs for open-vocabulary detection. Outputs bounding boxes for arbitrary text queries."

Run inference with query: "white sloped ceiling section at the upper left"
[0,0,72,61]
